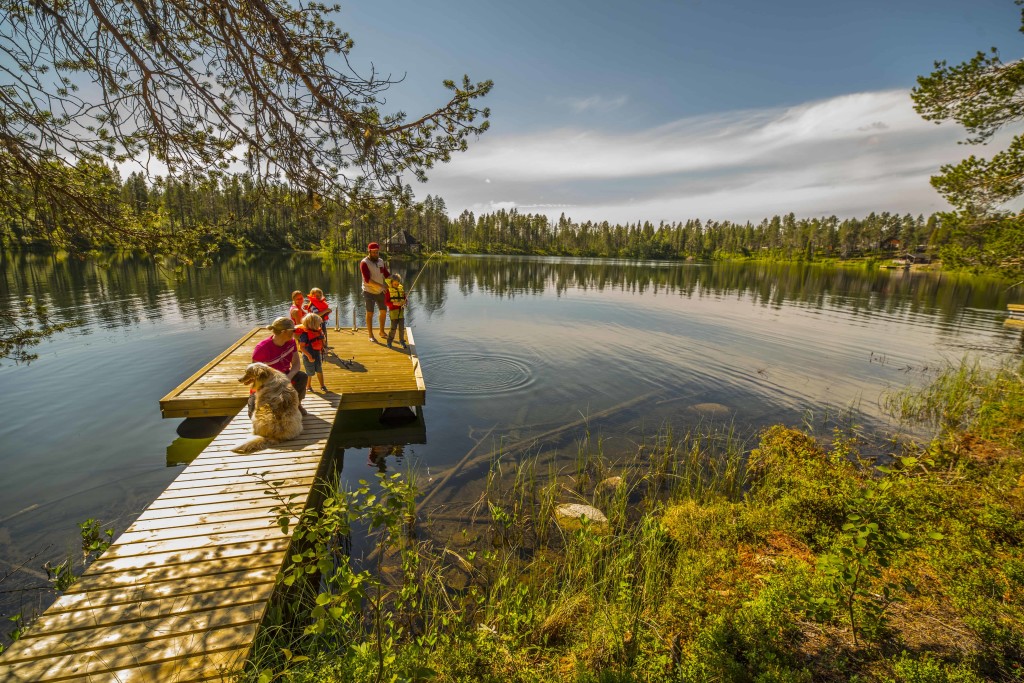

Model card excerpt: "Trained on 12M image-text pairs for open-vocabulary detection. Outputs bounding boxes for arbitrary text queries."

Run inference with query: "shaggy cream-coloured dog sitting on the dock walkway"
[231,362,302,453]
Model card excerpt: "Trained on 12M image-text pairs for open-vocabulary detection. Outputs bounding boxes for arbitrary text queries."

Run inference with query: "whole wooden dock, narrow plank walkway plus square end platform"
[0,329,425,683]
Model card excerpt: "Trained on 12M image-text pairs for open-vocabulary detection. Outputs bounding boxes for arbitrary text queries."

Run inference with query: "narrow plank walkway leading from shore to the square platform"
[0,393,344,683]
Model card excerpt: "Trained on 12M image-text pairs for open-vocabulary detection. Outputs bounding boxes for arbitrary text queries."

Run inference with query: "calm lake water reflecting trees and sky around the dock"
[0,254,1024,626]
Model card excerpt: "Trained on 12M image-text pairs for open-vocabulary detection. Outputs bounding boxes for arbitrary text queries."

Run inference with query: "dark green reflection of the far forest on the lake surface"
[0,253,1022,334]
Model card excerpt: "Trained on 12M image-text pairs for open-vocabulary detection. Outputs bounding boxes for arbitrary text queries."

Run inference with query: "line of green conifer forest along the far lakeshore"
[0,167,955,260]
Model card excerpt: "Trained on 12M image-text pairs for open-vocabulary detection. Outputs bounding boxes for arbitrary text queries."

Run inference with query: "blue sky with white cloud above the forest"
[338,0,1024,224]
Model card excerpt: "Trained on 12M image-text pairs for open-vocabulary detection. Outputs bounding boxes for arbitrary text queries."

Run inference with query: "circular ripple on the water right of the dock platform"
[423,354,534,395]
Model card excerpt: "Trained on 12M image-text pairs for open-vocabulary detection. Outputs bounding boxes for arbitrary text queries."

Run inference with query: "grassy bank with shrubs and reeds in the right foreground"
[243,365,1024,683]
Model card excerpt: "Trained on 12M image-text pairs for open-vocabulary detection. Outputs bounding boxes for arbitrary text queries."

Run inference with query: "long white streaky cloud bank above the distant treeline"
[419,90,1019,222]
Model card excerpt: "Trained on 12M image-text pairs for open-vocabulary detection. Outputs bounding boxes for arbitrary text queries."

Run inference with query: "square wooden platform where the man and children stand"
[160,328,426,418]
